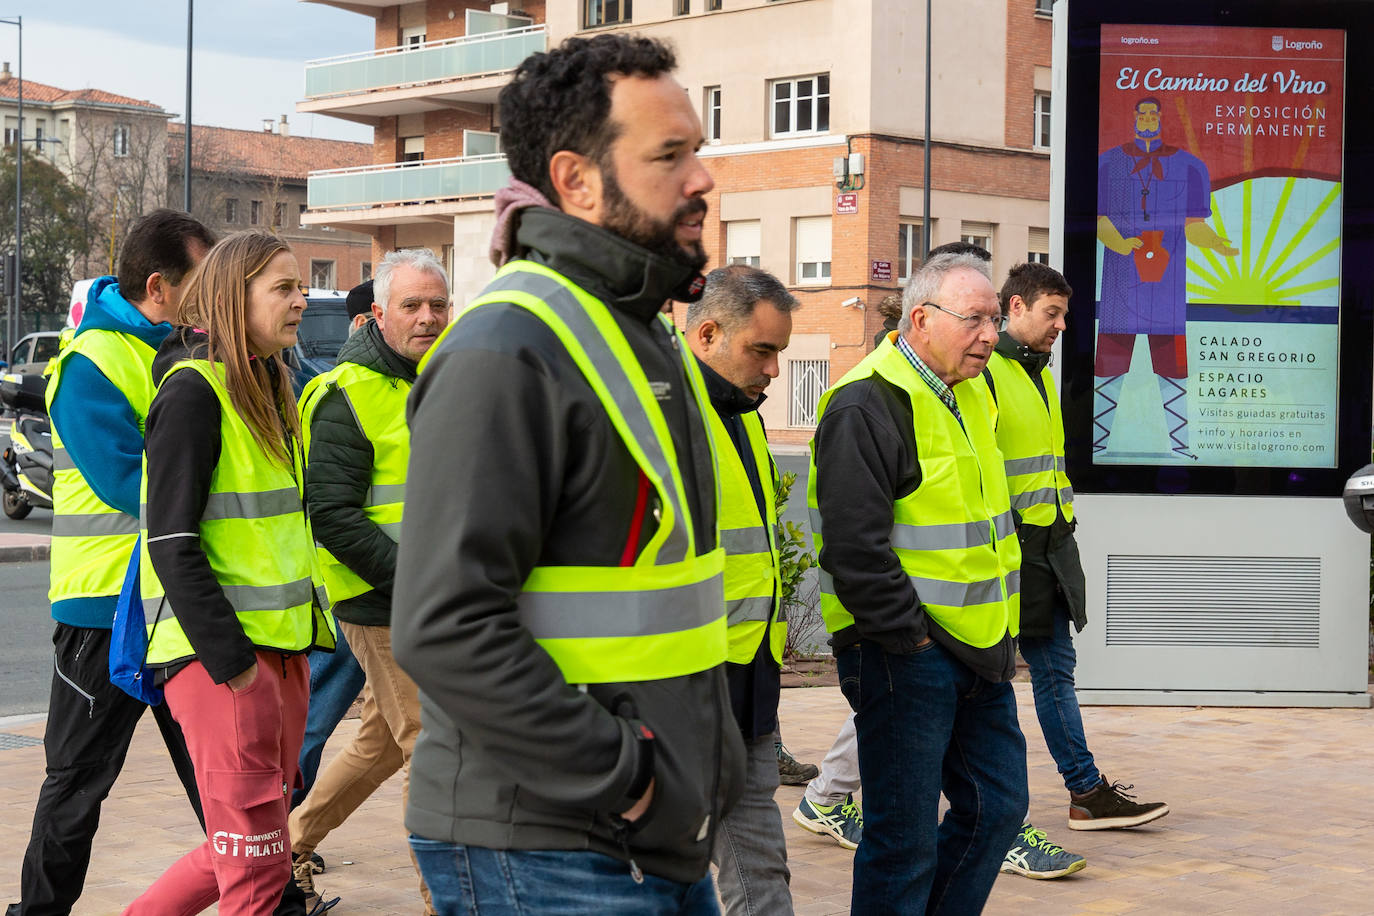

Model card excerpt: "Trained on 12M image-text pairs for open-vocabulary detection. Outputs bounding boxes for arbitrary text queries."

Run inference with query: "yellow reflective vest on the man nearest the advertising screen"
[988,352,1073,527]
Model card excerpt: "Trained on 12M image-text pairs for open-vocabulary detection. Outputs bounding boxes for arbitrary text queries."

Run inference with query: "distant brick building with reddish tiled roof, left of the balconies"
[166,114,372,290]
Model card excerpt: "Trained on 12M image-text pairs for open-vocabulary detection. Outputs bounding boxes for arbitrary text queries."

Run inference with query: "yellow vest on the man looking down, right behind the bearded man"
[708,409,787,665]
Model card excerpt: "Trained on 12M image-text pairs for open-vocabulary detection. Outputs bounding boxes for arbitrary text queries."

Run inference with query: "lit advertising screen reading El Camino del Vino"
[1091,23,1347,468]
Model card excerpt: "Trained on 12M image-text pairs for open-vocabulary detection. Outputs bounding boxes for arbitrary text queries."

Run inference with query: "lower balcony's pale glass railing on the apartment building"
[305,154,510,216]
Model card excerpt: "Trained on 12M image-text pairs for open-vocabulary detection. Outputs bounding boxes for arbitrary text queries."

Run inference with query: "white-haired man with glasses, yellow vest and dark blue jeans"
[807,254,1028,915]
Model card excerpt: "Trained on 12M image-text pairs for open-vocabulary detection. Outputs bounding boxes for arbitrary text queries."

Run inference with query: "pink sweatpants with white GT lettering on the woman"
[124,652,311,916]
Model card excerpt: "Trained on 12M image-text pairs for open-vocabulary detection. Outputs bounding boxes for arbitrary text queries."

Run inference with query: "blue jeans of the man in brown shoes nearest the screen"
[1021,604,1102,795]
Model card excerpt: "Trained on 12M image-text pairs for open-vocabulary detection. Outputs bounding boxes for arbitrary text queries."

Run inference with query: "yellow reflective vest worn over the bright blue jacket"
[44,328,157,602]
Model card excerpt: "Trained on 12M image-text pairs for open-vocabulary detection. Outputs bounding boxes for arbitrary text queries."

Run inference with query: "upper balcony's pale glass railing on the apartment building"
[305,25,547,103]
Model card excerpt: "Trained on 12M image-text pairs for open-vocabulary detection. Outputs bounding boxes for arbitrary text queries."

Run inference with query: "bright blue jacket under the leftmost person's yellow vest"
[51,276,172,629]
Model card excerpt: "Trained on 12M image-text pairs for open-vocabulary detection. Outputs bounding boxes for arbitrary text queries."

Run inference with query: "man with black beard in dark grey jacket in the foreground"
[392,34,743,916]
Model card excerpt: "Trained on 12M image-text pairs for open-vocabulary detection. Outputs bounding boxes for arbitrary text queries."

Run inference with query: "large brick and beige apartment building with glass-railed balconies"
[297,0,1052,444]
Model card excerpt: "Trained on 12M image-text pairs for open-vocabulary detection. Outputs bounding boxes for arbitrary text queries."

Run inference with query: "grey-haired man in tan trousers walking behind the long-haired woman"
[290,249,448,912]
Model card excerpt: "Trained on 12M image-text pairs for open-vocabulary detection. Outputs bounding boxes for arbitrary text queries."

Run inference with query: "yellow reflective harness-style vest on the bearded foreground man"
[420,261,725,684]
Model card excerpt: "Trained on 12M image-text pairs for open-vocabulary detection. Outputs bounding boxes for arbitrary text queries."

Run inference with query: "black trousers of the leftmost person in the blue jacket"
[7,623,205,916]
